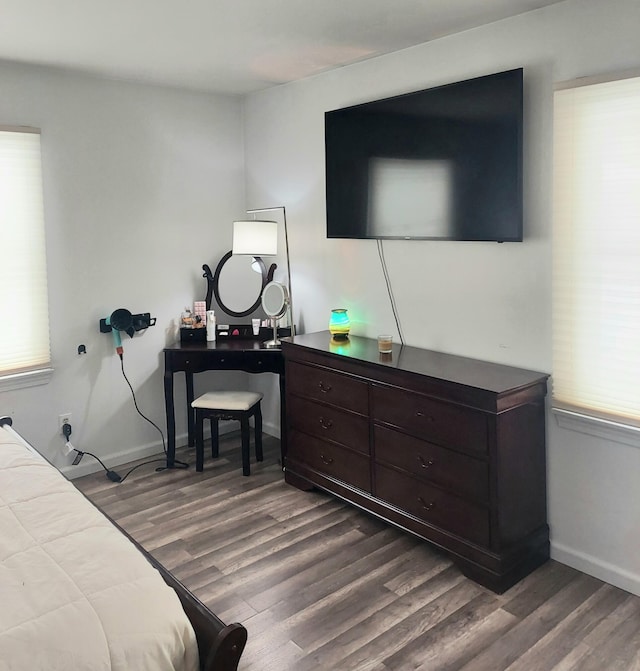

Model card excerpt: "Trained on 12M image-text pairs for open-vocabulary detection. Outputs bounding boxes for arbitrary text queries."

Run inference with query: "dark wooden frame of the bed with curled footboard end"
[0,417,247,671]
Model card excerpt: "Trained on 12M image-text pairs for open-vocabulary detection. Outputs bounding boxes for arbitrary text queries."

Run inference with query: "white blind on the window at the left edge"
[0,126,50,380]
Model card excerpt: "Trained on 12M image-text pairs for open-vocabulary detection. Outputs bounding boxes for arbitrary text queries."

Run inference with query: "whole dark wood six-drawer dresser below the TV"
[282,331,549,592]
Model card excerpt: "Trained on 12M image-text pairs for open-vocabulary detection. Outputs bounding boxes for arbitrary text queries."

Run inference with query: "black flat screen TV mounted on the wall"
[325,68,523,242]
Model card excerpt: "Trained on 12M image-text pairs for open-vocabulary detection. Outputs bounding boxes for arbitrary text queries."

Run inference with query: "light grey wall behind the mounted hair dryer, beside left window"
[0,63,245,474]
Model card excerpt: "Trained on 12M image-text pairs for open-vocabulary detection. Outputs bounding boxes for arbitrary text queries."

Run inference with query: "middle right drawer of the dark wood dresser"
[374,426,489,502]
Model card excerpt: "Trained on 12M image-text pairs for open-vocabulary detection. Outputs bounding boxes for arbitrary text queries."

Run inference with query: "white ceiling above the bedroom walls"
[0,0,561,94]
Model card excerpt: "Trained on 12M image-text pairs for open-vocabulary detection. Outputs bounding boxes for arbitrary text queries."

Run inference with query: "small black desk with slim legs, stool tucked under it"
[164,337,286,468]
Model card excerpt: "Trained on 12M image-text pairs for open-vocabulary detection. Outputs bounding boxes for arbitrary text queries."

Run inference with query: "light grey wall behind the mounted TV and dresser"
[245,0,640,594]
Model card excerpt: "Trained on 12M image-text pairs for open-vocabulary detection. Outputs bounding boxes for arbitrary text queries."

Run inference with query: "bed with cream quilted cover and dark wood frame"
[0,417,247,671]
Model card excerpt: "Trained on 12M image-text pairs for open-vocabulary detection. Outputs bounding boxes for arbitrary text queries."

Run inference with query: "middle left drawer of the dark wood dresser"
[287,396,369,456]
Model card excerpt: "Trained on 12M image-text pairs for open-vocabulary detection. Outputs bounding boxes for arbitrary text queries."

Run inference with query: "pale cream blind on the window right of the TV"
[553,77,640,426]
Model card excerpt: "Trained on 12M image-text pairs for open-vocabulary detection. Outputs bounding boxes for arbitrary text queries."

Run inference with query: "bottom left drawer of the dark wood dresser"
[286,431,371,492]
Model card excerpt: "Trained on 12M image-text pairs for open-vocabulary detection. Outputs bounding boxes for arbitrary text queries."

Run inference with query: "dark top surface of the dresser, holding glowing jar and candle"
[282,331,549,394]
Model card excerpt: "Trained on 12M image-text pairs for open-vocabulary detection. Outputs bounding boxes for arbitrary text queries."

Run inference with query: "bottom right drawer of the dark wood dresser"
[375,464,489,547]
